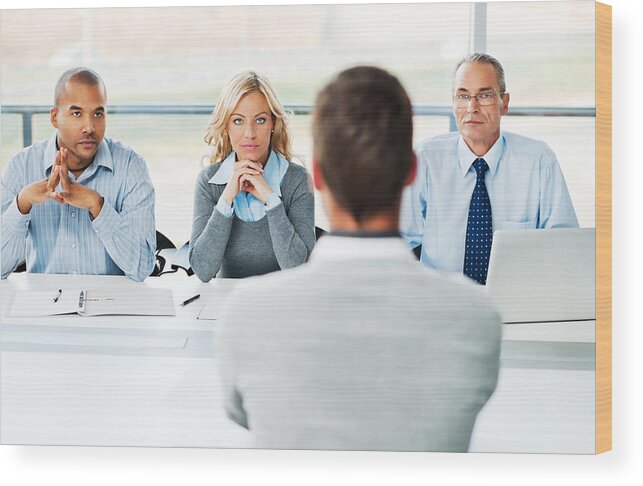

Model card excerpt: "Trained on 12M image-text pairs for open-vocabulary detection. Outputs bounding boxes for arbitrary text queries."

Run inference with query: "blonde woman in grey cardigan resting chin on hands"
[190,72,315,282]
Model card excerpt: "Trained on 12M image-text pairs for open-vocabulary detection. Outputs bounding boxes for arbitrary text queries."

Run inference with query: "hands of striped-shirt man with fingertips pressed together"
[17,148,104,219]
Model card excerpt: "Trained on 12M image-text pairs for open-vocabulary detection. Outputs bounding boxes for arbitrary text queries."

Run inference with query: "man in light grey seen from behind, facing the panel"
[215,67,501,451]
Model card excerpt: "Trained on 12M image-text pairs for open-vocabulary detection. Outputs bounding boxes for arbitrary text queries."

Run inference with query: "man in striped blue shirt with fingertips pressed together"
[2,68,156,280]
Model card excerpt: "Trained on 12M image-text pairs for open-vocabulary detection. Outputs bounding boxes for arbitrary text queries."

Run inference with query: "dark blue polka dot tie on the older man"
[464,159,493,285]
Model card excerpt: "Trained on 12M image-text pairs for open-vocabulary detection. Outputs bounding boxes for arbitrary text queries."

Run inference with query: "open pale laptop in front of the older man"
[486,228,596,323]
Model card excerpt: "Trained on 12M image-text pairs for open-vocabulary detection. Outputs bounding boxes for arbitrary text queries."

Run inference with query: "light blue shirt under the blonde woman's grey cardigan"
[208,151,288,221]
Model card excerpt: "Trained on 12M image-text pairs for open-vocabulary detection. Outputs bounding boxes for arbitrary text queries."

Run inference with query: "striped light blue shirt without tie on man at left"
[1,135,156,280]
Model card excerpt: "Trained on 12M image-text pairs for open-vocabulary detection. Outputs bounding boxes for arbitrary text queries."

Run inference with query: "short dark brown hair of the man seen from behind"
[313,66,413,222]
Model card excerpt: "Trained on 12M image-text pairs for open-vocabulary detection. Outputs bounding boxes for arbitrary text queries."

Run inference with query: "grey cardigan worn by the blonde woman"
[190,162,315,282]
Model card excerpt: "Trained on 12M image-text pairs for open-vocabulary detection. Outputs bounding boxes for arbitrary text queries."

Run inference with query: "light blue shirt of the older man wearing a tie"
[400,132,578,272]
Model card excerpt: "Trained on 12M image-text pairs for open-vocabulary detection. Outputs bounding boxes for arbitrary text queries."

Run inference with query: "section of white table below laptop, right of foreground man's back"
[469,321,596,454]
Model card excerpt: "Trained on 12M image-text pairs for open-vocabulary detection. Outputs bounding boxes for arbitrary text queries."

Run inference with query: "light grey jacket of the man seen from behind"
[216,235,501,451]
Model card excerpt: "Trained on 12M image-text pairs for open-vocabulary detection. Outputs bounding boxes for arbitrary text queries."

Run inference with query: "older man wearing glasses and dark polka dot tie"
[400,53,578,284]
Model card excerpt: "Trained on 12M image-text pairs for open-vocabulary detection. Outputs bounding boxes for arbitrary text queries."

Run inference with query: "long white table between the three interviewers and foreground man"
[0,274,595,453]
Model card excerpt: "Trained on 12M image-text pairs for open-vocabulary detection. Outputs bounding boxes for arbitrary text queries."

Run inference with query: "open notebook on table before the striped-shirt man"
[9,287,176,317]
